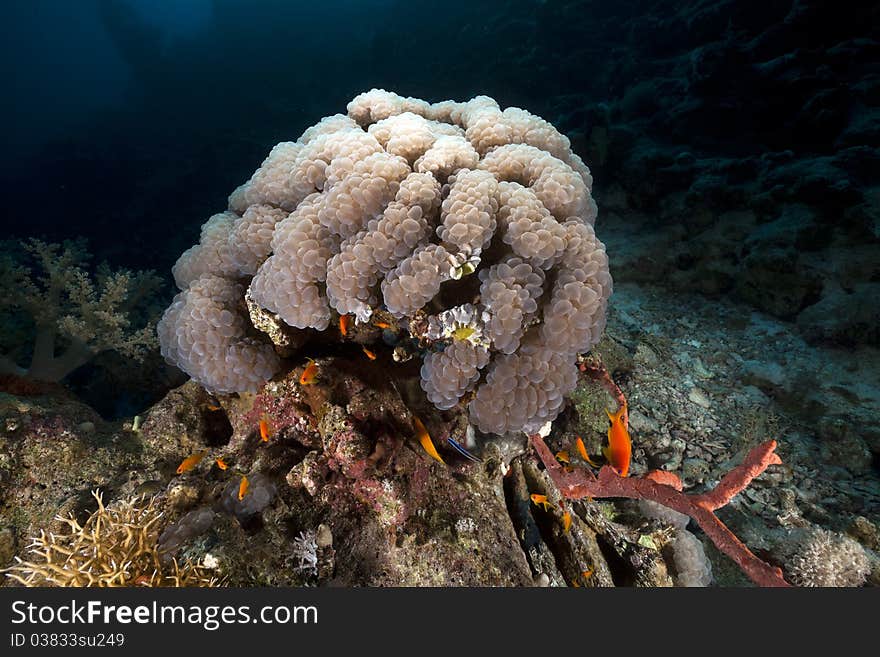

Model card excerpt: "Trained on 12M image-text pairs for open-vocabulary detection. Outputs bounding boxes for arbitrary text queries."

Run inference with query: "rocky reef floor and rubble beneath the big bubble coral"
[0,276,880,586]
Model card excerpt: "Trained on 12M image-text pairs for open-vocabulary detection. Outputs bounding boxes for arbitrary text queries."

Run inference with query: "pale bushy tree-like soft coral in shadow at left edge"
[0,240,161,381]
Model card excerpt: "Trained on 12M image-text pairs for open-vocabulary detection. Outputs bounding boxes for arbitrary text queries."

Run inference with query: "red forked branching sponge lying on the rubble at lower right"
[530,434,789,586]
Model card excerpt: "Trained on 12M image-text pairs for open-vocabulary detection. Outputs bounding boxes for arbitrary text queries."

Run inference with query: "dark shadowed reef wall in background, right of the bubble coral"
[535,1,880,346]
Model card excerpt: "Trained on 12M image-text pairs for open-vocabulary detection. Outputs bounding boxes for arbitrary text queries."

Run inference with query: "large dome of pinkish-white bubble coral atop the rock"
[159,89,612,434]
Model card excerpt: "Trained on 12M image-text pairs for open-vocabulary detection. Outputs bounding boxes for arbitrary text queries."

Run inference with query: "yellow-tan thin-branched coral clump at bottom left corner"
[6,491,218,586]
